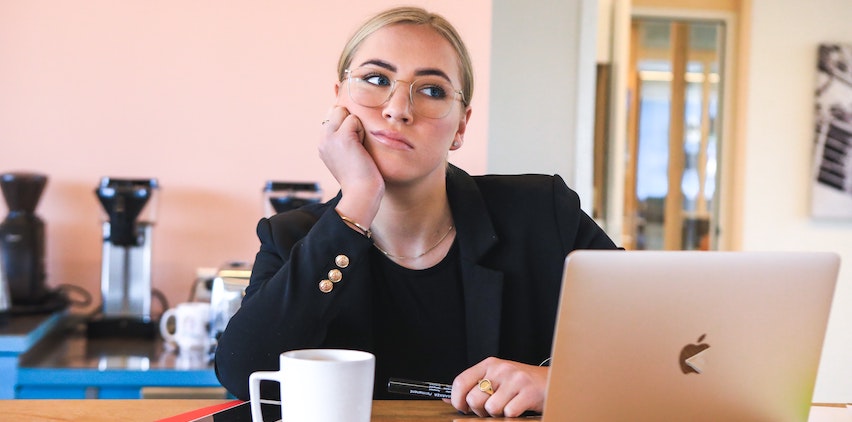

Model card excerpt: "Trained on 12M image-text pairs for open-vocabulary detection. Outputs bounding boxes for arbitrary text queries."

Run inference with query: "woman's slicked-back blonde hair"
[337,7,473,107]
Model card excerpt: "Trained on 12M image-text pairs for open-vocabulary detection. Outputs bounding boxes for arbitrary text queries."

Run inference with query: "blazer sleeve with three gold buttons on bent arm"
[215,210,372,400]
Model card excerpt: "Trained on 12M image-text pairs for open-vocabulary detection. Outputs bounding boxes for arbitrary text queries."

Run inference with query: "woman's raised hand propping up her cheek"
[319,106,385,227]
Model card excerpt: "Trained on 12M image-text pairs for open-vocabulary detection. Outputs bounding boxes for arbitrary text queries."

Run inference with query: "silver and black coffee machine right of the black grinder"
[87,177,159,338]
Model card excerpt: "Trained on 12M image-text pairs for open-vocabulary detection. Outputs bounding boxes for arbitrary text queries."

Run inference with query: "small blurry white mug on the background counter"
[160,302,211,353]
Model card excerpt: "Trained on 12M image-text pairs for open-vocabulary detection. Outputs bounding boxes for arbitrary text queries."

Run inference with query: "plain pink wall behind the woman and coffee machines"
[0,0,491,312]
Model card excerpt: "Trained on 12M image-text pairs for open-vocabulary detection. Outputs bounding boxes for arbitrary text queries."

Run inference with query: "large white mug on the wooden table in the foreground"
[249,349,376,422]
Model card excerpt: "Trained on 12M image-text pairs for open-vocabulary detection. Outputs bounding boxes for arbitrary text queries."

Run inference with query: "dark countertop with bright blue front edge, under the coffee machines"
[16,316,225,398]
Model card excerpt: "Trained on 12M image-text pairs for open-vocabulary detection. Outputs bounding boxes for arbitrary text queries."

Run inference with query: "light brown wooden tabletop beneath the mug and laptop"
[0,399,852,422]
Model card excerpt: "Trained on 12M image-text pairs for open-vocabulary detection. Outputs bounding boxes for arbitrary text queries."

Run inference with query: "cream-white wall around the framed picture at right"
[741,0,852,402]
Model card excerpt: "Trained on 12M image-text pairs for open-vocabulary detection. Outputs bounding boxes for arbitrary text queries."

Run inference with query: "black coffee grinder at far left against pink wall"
[0,172,51,313]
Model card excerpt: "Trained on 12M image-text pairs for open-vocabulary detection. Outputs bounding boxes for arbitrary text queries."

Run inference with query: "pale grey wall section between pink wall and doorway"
[488,0,598,211]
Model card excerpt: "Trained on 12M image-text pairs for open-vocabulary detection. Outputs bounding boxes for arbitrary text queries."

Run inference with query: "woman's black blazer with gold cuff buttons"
[215,166,616,399]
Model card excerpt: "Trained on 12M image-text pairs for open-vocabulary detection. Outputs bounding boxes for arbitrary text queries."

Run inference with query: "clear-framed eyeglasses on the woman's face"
[346,67,464,119]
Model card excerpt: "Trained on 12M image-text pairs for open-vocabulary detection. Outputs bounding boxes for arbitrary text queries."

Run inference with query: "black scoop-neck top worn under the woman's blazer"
[373,243,468,400]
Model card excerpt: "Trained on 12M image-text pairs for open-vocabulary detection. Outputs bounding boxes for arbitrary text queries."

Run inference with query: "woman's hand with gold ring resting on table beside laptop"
[444,357,549,417]
